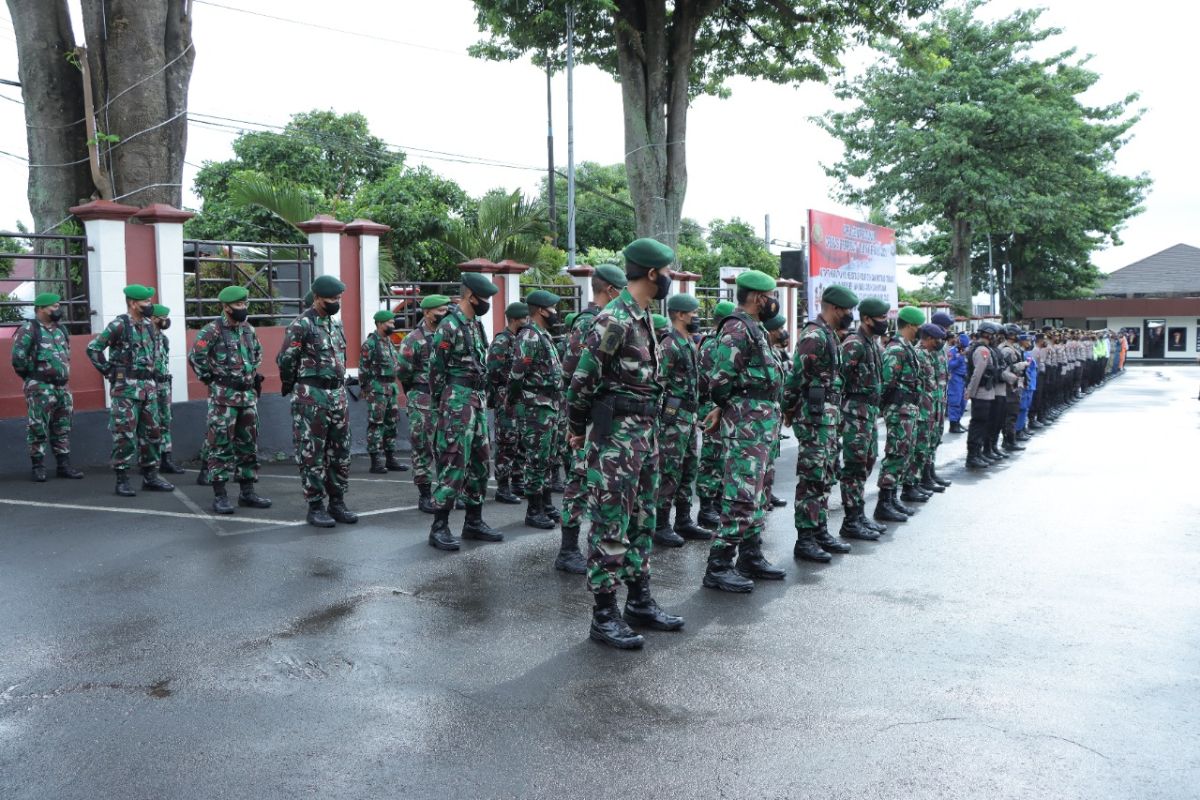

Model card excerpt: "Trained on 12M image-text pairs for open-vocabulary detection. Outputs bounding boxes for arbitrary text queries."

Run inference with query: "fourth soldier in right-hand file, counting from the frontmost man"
[838,297,904,541]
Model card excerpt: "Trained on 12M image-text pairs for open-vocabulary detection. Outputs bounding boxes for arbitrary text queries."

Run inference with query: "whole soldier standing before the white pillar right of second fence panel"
[275,275,359,528]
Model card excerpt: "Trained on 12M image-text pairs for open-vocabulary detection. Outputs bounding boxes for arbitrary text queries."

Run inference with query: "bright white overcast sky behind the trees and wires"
[0,0,1200,285]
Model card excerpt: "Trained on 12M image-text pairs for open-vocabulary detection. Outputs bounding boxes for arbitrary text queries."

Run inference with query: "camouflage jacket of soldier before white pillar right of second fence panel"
[275,308,346,409]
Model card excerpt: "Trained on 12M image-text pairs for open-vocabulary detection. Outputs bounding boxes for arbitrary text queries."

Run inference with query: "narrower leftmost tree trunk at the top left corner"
[8,0,95,233]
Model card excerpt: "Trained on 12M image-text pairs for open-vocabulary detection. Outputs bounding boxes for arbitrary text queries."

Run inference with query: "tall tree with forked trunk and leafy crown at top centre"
[472,0,940,246]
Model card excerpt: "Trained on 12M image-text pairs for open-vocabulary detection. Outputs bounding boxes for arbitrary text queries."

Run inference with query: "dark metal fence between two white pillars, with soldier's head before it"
[184,239,313,327]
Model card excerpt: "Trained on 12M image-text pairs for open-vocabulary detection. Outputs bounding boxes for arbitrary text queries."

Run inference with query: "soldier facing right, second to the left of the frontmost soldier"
[505,289,563,530]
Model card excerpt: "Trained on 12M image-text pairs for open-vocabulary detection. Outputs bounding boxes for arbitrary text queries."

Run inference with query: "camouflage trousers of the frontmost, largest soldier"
[585,434,659,594]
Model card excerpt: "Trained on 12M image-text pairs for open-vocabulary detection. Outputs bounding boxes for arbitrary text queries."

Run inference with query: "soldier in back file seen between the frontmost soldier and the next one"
[654,294,713,547]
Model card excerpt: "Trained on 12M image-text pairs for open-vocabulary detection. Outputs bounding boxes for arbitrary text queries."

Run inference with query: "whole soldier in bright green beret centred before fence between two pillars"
[187,285,271,513]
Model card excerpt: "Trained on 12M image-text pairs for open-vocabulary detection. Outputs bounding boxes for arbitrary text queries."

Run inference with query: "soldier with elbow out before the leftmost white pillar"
[88,283,175,498]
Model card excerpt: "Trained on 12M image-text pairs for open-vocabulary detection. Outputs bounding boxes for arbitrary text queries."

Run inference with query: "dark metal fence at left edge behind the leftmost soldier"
[0,231,91,333]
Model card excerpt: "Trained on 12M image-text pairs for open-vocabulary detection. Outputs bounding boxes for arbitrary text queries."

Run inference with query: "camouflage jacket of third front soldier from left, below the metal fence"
[187,317,263,408]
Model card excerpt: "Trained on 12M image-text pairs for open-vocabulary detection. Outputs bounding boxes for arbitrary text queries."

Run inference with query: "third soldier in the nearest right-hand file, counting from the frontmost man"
[784,283,858,563]
